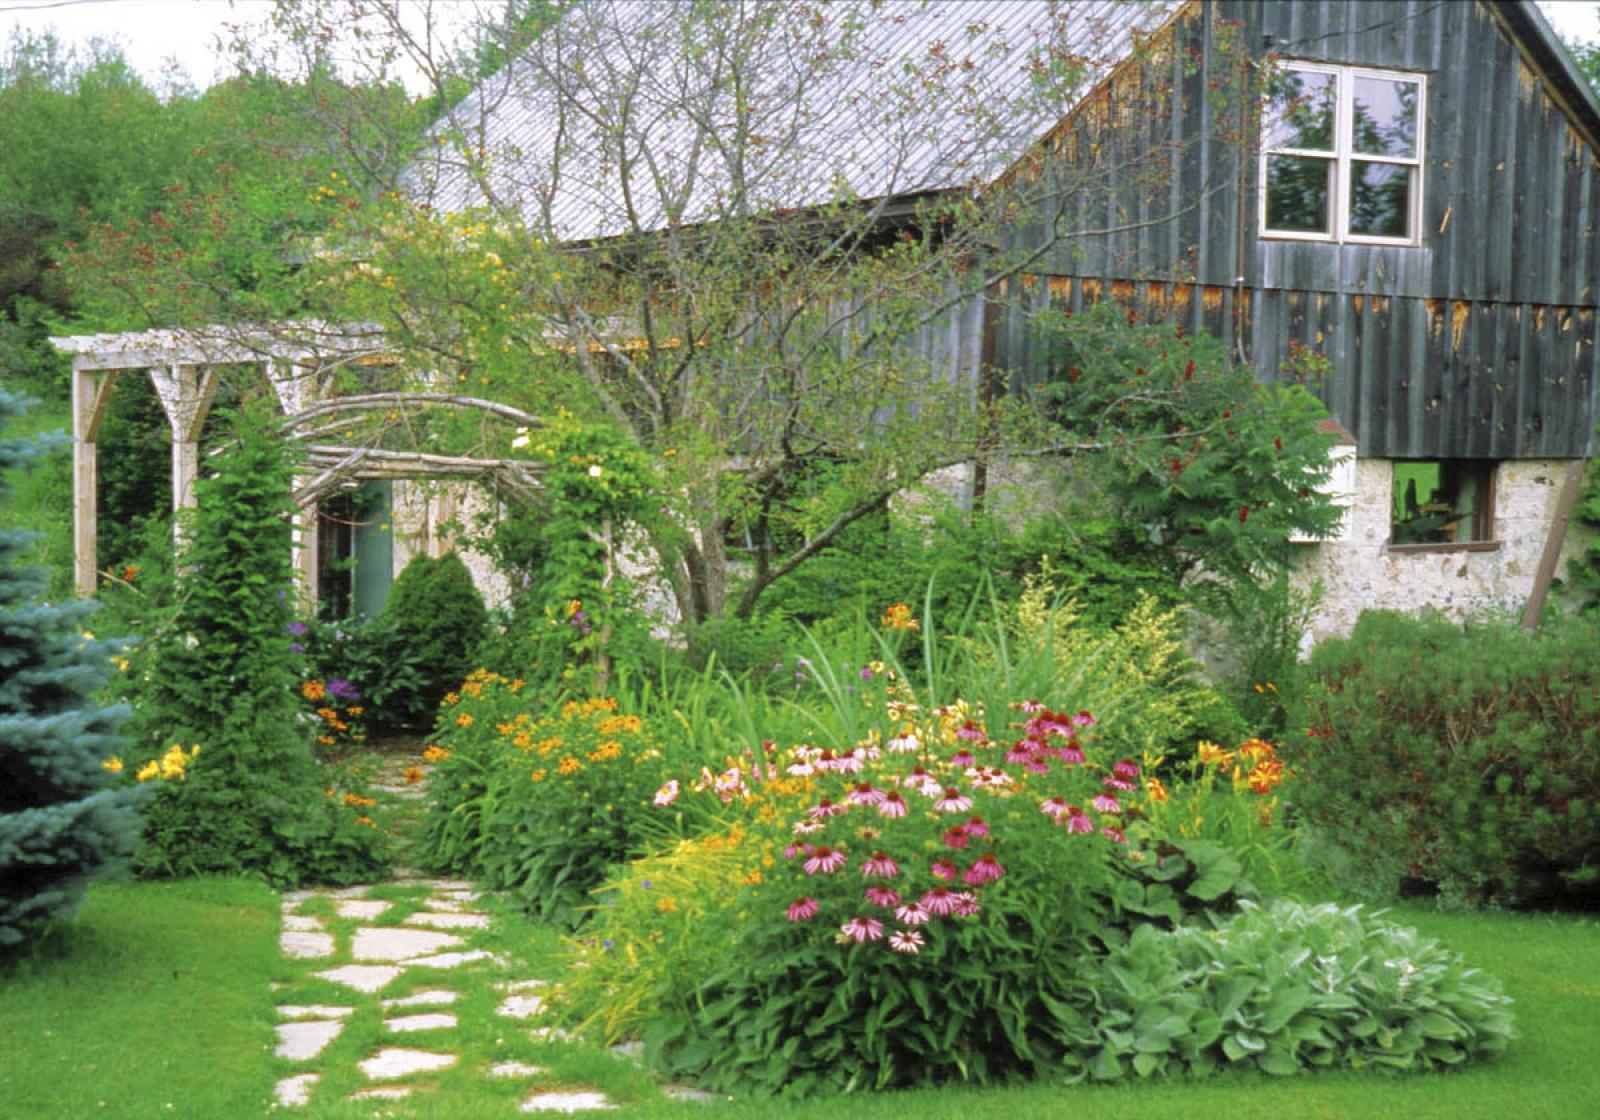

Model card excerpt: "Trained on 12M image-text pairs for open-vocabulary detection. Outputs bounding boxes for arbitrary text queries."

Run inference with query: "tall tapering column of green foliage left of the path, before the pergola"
[116,413,381,883]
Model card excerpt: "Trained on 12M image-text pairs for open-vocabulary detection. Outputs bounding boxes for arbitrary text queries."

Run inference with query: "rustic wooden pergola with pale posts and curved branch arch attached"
[51,323,539,598]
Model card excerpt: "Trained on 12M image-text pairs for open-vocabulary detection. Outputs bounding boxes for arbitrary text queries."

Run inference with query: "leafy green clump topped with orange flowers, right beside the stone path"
[424,670,720,923]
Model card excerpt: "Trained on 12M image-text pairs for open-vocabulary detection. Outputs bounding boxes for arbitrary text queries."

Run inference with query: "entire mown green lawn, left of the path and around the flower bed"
[0,880,1600,1120]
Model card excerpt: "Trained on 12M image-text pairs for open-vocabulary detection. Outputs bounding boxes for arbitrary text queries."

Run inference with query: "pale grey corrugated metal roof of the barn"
[411,0,1181,240]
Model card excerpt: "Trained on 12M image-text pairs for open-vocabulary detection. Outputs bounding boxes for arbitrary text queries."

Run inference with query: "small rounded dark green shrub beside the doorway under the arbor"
[379,552,488,728]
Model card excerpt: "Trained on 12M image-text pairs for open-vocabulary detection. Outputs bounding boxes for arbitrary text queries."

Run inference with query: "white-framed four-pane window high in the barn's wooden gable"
[1261,62,1427,245]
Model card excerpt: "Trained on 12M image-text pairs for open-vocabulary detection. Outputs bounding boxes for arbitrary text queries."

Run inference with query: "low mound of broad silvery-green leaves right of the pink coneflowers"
[1088,902,1514,1082]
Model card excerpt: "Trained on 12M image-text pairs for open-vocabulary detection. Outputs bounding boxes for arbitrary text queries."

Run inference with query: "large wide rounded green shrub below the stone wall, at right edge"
[1285,611,1600,902]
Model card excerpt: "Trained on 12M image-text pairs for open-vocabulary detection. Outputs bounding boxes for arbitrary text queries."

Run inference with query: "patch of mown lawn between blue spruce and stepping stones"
[0,880,277,1120]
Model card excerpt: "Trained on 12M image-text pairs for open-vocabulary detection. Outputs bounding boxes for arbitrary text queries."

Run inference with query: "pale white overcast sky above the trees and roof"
[0,0,1600,86]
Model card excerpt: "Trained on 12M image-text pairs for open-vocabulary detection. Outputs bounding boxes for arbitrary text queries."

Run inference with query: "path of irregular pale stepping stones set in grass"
[274,878,643,1114]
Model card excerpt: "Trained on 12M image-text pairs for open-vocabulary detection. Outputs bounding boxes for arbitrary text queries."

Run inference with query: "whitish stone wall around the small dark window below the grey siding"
[1296,459,1581,642]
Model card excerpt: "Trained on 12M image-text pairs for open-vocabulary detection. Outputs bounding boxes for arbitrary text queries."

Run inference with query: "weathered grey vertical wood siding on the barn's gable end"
[995,0,1600,459]
